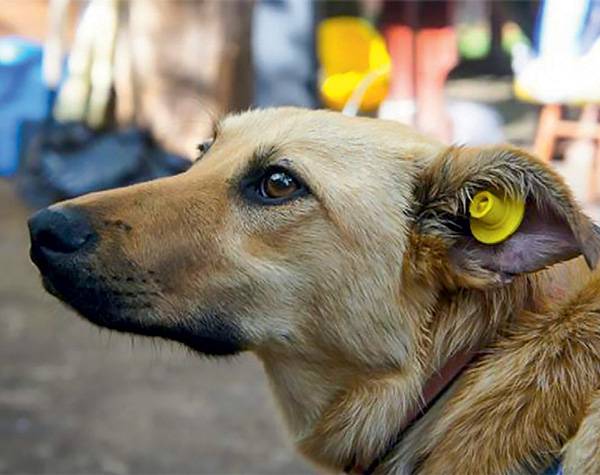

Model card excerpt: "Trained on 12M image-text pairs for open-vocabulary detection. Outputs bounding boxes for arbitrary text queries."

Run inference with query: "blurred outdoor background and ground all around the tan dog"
[0,0,600,474]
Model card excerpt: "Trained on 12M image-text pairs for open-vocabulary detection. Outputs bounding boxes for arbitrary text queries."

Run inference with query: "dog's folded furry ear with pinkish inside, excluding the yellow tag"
[414,147,600,286]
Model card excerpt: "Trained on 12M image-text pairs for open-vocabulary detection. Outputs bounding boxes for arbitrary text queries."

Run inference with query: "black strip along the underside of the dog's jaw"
[42,275,248,356]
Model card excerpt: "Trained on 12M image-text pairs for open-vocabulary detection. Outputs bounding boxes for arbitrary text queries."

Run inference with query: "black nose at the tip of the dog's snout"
[28,206,95,254]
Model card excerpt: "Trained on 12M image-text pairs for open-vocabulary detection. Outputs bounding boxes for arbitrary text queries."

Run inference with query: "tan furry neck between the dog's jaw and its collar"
[260,282,527,470]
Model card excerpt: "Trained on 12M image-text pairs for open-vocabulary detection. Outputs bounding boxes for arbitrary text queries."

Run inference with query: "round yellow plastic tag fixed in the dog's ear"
[469,191,525,244]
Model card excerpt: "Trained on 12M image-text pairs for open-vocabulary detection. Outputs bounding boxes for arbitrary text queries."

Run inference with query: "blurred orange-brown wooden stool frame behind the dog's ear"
[533,104,600,201]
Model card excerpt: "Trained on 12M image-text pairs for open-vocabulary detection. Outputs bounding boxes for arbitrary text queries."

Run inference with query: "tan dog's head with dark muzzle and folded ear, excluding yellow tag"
[29,109,599,365]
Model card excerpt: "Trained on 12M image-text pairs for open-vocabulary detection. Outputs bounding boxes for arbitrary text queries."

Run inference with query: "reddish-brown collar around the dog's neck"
[345,350,478,475]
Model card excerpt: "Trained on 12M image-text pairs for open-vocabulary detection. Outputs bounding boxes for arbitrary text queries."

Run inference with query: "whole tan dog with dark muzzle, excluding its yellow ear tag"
[29,108,600,475]
